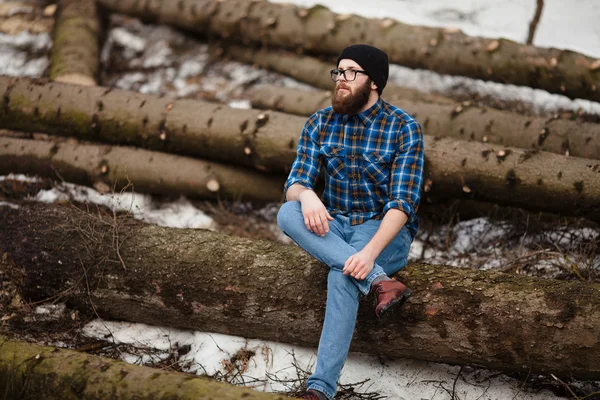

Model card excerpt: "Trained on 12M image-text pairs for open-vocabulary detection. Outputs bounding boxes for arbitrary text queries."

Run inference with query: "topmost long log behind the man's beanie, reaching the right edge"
[99,0,600,101]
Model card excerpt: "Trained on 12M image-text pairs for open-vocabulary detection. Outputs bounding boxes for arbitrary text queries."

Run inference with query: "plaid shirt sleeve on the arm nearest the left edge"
[284,113,321,197]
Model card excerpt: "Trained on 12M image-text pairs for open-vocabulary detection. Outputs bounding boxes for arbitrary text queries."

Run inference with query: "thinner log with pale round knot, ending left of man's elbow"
[0,136,285,201]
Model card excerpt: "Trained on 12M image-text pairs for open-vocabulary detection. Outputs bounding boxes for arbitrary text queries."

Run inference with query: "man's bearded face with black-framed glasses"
[331,58,372,115]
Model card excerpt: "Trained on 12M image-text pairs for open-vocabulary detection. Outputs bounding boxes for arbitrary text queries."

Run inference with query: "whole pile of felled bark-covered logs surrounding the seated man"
[0,0,600,399]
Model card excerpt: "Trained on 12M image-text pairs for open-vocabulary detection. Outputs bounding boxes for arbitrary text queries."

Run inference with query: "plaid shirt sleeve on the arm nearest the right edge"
[383,120,425,219]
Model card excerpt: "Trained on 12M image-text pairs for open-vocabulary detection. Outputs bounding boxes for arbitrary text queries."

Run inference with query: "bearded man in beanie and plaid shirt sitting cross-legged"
[277,44,423,400]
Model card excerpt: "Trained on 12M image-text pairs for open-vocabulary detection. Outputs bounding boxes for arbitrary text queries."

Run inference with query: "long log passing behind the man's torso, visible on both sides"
[0,78,600,221]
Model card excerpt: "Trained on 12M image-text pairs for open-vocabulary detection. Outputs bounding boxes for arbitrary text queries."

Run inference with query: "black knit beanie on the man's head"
[336,44,390,96]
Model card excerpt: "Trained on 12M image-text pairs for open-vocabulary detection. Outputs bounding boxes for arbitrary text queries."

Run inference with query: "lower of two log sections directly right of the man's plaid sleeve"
[424,136,600,221]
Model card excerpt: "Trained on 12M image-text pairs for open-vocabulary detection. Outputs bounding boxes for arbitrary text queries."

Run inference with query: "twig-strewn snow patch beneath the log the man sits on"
[79,320,560,400]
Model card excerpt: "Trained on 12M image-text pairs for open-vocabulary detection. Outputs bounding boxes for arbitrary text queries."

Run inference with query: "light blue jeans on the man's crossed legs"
[277,201,412,399]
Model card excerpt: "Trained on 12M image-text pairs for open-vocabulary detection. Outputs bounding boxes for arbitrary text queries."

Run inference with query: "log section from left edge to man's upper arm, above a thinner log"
[0,77,304,171]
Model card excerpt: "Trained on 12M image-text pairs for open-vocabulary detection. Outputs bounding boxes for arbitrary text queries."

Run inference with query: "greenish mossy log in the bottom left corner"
[0,337,285,400]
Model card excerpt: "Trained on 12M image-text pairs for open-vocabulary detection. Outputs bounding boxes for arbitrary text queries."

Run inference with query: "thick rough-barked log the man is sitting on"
[0,204,600,379]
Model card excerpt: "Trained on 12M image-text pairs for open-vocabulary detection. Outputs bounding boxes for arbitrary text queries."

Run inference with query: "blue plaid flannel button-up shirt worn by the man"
[285,99,424,237]
